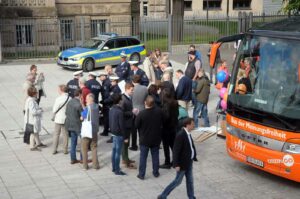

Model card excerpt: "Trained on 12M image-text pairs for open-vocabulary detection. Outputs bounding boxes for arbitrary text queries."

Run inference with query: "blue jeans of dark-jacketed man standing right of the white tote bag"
[111,136,124,173]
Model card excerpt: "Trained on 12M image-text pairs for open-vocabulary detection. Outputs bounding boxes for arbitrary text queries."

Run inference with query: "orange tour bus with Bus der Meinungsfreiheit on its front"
[210,17,300,182]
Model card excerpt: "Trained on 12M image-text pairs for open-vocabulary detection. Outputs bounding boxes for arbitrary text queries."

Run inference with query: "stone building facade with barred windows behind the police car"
[0,0,140,58]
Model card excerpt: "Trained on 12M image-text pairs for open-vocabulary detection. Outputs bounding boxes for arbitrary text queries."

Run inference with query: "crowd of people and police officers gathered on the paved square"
[24,45,218,198]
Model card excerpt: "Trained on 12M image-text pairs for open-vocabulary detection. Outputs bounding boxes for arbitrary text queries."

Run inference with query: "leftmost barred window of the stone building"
[16,25,33,46]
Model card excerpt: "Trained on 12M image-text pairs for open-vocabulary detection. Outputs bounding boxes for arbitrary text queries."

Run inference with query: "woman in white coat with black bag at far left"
[24,87,46,151]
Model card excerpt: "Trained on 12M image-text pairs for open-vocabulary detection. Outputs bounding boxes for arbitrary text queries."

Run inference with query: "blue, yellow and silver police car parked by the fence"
[57,33,146,71]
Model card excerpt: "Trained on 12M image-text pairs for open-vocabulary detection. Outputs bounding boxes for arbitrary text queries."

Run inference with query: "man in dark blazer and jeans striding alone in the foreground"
[157,118,197,199]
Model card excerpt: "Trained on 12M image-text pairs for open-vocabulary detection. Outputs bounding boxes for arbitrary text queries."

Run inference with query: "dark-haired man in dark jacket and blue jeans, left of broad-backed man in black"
[109,93,128,175]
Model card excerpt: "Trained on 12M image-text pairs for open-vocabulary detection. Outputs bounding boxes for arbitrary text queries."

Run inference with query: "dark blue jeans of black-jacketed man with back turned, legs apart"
[139,145,159,177]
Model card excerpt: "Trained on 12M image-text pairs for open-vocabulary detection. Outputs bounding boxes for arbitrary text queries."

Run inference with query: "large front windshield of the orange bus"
[229,35,300,127]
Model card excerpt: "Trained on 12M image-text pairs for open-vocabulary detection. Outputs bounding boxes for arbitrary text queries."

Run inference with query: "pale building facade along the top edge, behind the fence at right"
[140,0,282,18]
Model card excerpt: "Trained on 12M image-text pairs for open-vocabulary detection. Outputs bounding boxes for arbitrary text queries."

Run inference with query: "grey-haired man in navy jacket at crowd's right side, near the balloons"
[176,70,193,114]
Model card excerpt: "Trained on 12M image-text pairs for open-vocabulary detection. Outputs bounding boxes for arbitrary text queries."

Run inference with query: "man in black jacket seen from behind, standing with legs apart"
[135,96,163,180]
